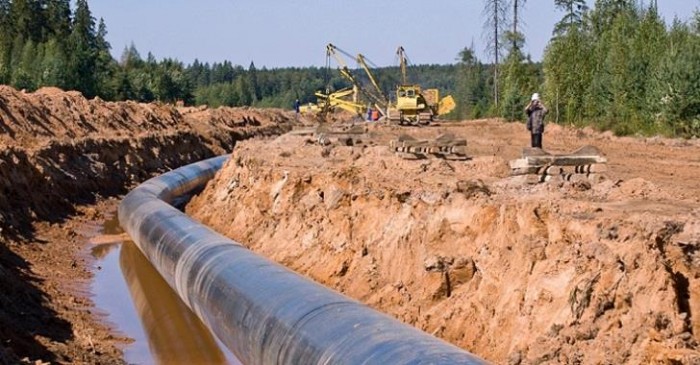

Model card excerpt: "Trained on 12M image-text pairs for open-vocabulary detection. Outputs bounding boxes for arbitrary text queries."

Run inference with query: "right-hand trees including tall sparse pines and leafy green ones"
[478,0,700,136]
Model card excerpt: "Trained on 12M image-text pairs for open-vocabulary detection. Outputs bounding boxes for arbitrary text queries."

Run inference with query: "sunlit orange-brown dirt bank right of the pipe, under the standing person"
[187,121,700,364]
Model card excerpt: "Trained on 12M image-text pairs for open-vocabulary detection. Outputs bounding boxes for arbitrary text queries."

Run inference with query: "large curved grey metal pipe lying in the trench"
[119,156,485,364]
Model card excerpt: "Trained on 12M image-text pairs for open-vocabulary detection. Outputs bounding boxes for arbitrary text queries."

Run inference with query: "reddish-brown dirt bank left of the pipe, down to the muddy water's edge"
[0,86,295,363]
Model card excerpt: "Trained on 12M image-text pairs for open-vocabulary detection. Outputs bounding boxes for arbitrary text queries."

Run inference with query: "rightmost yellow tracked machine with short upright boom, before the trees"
[387,47,456,125]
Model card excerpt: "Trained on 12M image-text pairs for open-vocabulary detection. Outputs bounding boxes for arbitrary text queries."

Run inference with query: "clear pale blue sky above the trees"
[89,0,700,68]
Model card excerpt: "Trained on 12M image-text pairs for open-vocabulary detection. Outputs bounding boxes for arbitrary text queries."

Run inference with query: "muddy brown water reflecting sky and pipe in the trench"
[92,214,240,364]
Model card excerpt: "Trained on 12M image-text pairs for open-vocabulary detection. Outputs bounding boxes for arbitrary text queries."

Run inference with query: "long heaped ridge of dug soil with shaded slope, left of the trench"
[0,86,294,239]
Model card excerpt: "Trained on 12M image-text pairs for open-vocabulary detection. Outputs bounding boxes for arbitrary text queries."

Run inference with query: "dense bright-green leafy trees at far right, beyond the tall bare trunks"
[543,0,700,136]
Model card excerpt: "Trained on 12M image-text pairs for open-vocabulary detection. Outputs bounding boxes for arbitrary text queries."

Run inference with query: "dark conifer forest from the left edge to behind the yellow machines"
[0,0,464,108]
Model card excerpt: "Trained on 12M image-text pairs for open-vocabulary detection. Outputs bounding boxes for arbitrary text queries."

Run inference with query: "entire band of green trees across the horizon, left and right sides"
[0,0,700,136]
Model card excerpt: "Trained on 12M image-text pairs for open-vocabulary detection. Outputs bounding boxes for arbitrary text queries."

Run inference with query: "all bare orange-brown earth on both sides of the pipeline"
[0,87,700,364]
